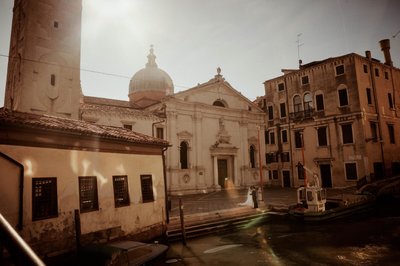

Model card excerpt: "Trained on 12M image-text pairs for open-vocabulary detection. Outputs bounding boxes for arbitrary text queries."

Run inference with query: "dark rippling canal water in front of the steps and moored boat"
[157,202,400,266]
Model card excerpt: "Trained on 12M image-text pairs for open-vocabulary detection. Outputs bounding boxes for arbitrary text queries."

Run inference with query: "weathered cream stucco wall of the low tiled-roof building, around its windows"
[0,145,165,253]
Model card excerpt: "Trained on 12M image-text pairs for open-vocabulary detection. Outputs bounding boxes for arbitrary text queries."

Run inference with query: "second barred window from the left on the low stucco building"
[79,176,99,212]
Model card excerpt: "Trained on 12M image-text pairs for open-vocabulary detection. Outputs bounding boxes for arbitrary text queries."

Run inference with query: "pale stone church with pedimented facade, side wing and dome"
[81,51,265,194]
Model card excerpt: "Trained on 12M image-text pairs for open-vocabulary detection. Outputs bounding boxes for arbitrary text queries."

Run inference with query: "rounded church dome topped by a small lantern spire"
[129,46,174,107]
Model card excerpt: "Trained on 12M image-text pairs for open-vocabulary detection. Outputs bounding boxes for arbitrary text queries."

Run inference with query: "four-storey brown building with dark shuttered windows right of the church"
[256,40,400,187]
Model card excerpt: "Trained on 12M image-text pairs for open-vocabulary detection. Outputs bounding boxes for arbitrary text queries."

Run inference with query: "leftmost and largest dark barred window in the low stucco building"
[32,177,58,221]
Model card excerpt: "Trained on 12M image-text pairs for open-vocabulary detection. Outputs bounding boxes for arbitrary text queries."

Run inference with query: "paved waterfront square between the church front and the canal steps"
[169,187,355,217]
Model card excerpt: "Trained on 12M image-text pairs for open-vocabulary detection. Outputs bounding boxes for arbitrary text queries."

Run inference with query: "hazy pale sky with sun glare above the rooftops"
[0,0,400,106]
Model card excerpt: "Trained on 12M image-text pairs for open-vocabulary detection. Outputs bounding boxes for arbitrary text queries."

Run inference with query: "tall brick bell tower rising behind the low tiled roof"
[4,0,82,119]
